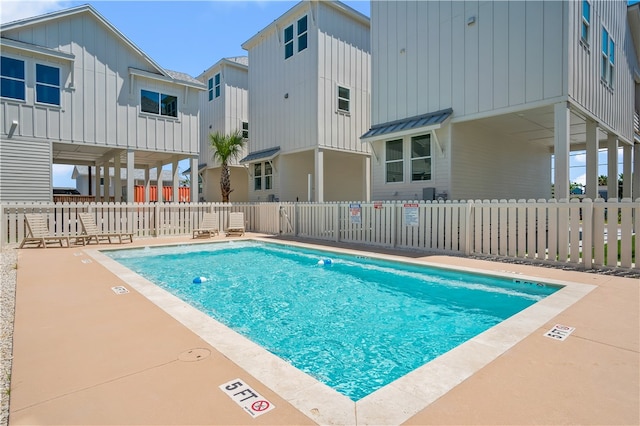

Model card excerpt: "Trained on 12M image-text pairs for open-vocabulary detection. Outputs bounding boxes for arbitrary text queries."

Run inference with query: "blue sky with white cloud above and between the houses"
[0,0,638,187]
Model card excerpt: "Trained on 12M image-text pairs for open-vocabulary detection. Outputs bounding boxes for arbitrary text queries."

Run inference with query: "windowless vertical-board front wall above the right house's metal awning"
[371,1,568,125]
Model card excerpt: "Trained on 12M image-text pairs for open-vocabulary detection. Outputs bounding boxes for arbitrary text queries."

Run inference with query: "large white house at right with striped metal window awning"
[362,0,640,199]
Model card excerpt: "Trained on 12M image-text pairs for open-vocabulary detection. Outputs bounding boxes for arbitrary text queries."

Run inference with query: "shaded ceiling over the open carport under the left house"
[52,142,192,168]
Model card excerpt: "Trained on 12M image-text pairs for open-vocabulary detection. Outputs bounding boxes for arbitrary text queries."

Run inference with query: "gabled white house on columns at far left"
[0,5,204,201]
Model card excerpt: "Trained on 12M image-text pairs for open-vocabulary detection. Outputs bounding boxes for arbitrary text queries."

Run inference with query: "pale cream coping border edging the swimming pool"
[84,237,596,424]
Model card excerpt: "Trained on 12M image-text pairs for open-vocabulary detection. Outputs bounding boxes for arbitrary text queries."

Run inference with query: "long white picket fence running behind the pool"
[0,199,640,269]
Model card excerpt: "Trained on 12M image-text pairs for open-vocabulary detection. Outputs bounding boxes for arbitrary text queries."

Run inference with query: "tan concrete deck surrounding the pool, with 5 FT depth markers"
[9,237,640,425]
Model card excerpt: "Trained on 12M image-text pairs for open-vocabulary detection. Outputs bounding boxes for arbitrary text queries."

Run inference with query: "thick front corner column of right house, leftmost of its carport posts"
[553,102,571,200]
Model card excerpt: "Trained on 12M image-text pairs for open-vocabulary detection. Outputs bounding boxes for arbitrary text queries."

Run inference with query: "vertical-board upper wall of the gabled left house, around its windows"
[2,12,199,154]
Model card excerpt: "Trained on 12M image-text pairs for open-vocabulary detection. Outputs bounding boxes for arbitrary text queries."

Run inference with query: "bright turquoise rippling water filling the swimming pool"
[105,241,559,401]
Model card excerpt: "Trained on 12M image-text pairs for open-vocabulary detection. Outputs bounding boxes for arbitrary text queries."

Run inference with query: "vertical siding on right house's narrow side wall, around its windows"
[567,0,638,141]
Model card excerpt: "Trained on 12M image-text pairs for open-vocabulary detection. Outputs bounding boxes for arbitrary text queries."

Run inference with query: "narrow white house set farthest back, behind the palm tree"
[197,56,250,202]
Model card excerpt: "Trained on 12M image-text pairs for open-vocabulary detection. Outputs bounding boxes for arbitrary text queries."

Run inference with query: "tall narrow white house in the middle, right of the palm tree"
[242,1,371,201]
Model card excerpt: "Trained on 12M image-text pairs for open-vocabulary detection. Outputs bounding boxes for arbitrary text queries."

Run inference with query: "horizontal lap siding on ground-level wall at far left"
[0,138,52,202]
